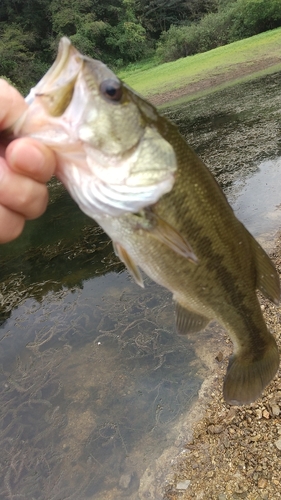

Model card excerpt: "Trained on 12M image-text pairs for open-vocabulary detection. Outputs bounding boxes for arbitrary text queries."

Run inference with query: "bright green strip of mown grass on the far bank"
[119,28,281,101]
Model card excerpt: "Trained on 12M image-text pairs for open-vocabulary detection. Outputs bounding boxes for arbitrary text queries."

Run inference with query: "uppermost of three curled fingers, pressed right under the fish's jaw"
[6,137,56,182]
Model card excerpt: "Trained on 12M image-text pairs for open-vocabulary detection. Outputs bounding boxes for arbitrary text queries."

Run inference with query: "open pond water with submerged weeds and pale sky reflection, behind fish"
[0,73,281,500]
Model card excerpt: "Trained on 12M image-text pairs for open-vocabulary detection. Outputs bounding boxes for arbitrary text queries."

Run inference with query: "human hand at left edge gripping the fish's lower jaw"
[0,79,56,243]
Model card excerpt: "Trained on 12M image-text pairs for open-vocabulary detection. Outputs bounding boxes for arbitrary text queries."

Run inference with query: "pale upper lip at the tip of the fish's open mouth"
[25,37,83,105]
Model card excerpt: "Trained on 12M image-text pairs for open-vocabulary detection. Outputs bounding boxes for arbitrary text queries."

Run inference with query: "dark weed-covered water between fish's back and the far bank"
[164,68,281,189]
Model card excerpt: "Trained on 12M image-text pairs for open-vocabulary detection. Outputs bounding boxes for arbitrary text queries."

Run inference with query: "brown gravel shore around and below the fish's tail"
[164,235,281,500]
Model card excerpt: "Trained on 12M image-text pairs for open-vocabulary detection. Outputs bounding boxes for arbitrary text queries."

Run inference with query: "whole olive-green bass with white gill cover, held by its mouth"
[8,38,280,405]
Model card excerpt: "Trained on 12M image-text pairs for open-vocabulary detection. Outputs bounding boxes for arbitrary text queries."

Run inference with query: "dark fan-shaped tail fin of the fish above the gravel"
[223,335,280,406]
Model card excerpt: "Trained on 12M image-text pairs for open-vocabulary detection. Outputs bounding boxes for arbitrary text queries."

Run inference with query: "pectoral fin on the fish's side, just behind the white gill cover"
[142,214,198,264]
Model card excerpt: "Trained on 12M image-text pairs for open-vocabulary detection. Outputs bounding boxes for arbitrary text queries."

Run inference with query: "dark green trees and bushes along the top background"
[0,0,281,93]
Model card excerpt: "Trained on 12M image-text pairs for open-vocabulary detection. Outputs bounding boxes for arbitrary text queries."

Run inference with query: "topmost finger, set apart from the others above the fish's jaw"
[0,78,28,130]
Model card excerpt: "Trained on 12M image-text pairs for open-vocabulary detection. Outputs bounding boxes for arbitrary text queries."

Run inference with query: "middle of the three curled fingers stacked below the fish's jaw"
[0,158,48,219]
